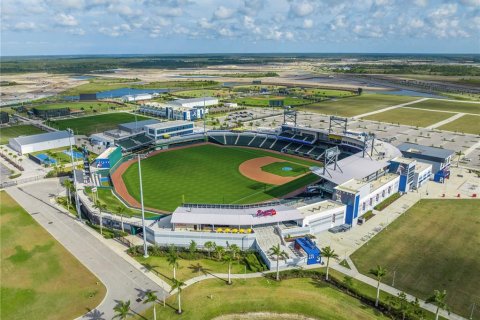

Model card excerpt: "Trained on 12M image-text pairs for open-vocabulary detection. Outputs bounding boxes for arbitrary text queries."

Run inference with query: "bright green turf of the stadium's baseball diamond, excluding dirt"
[123,145,319,211]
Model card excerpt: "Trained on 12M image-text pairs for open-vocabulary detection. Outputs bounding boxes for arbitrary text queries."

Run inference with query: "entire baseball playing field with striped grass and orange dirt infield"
[112,144,320,211]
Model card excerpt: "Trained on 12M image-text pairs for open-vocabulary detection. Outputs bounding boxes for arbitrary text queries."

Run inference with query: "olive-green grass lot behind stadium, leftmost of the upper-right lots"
[301,93,418,117]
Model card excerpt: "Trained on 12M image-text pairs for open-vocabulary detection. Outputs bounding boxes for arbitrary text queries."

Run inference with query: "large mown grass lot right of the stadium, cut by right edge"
[352,199,480,319]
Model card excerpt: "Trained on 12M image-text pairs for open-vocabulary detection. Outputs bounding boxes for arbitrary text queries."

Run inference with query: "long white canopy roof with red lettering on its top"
[171,205,303,226]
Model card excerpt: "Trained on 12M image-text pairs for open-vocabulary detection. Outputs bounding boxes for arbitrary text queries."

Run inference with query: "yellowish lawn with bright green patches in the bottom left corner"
[0,191,106,320]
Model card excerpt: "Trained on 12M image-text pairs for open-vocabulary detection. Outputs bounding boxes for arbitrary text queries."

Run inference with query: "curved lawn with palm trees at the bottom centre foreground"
[137,278,387,320]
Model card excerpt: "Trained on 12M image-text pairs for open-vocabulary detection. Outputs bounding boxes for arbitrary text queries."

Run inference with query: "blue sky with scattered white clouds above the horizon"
[1,0,480,56]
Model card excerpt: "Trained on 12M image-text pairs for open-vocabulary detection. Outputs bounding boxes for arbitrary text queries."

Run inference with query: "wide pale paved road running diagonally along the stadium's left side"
[7,180,164,320]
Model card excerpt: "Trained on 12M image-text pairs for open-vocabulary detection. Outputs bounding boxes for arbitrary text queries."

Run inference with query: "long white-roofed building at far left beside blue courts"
[8,131,75,154]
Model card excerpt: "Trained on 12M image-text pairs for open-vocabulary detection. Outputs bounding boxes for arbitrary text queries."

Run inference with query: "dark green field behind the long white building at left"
[48,112,150,135]
